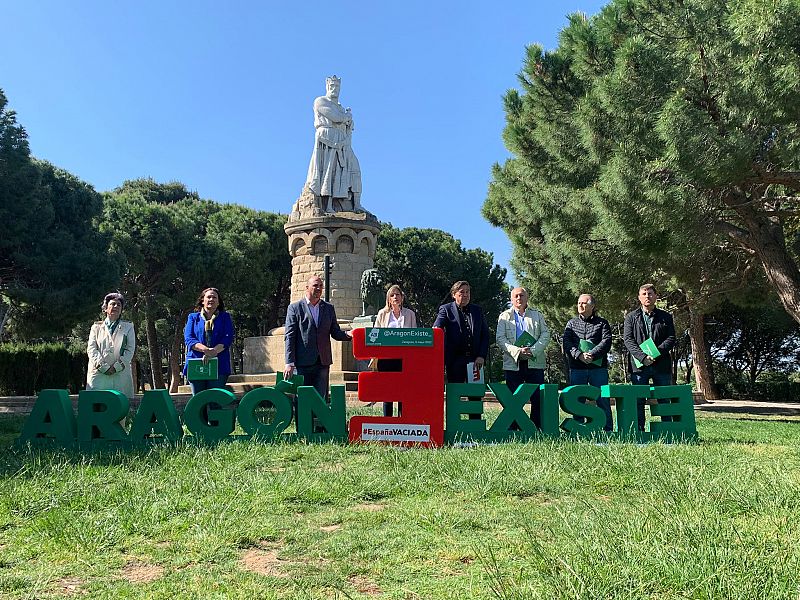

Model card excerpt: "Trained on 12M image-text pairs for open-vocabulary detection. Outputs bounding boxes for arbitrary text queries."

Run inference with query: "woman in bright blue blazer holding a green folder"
[183,288,234,394]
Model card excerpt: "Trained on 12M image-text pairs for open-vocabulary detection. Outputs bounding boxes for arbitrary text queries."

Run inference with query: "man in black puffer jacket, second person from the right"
[564,294,614,431]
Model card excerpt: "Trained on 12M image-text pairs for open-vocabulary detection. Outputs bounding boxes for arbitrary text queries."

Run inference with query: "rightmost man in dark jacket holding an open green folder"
[623,283,675,431]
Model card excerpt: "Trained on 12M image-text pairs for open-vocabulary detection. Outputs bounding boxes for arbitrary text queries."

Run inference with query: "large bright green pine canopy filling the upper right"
[483,0,800,321]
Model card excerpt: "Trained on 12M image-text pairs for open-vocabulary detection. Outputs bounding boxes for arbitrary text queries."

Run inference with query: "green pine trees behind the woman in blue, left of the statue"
[102,179,291,388]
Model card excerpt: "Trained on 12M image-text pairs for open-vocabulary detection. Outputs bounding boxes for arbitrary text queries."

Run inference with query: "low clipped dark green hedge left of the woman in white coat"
[0,343,89,396]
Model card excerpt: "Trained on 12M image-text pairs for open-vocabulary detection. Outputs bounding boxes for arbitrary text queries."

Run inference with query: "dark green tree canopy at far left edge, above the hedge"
[0,90,119,337]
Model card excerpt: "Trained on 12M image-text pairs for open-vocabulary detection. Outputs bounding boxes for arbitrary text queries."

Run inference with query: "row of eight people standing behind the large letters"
[86,276,675,431]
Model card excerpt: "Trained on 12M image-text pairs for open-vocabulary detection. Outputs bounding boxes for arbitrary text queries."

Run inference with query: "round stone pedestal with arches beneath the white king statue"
[284,212,380,321]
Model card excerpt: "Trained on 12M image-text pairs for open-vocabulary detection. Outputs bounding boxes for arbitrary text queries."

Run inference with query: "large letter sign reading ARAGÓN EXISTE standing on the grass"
[18,382,697,447]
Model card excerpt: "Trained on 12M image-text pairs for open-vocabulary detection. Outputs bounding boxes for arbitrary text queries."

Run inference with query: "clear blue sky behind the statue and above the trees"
[0,0,604,282]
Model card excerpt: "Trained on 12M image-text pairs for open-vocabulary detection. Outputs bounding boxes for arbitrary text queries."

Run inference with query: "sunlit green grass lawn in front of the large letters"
[0,414,800,599]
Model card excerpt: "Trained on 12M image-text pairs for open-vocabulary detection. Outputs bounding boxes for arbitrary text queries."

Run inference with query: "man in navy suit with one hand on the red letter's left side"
[283,275,352,398]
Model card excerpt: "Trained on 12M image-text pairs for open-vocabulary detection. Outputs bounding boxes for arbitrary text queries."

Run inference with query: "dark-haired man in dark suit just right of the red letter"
[433,281,489,419]
